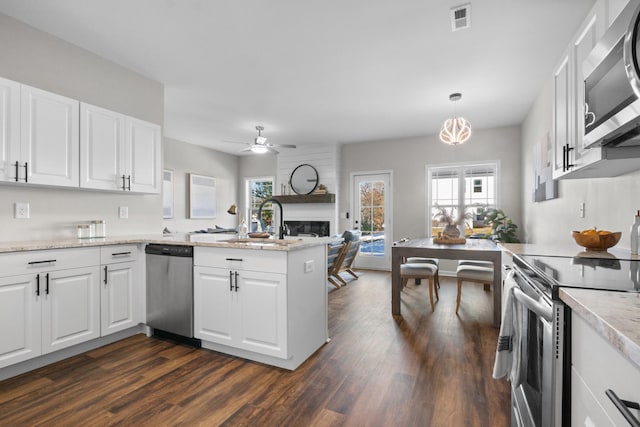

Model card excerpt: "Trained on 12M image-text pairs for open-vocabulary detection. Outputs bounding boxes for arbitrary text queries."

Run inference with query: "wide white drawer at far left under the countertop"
[0,248,100,277]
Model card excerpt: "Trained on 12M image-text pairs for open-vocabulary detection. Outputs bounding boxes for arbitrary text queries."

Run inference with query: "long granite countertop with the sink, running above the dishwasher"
[0,233,331,253]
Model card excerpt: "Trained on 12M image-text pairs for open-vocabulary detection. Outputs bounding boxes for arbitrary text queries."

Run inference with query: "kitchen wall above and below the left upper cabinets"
[0,14,164,241]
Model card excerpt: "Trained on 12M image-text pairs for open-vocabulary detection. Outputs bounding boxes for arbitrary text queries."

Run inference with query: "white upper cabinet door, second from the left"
[20,85,80,187]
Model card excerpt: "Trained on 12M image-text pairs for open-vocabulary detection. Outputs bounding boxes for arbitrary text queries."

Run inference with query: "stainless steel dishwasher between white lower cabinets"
[145,244,200,347]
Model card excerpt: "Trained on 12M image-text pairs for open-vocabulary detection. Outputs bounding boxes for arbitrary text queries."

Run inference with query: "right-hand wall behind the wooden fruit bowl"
[522,79,640,250]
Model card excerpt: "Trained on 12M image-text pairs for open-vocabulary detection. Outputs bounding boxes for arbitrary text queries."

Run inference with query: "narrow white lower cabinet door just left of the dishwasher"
[100,261,139,336]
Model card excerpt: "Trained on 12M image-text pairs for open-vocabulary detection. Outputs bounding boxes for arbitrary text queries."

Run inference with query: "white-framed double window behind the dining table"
[427,162,498,237]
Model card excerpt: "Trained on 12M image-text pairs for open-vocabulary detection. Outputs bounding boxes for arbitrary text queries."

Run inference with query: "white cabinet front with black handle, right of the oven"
[571,313,640,425]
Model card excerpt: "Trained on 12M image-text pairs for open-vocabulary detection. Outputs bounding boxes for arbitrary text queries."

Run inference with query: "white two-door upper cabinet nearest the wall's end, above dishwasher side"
[80,103,161,193]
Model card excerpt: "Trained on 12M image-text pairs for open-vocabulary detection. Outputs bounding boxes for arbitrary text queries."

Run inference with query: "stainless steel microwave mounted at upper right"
[582,0,640,147]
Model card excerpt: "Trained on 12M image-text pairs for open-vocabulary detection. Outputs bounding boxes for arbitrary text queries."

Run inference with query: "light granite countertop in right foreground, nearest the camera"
[560,288,640,368]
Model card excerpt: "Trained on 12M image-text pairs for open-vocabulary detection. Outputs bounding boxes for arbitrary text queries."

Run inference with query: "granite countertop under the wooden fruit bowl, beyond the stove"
[499,242,640,260]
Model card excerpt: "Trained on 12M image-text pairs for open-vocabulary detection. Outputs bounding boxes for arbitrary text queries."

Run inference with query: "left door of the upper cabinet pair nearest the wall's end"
[80,103,125,190]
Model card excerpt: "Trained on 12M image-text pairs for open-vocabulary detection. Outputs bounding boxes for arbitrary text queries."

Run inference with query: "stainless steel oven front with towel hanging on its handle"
[505,266,564,427]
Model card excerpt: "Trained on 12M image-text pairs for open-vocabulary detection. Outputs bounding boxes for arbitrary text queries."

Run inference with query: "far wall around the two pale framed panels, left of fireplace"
[163,138,241,232]
